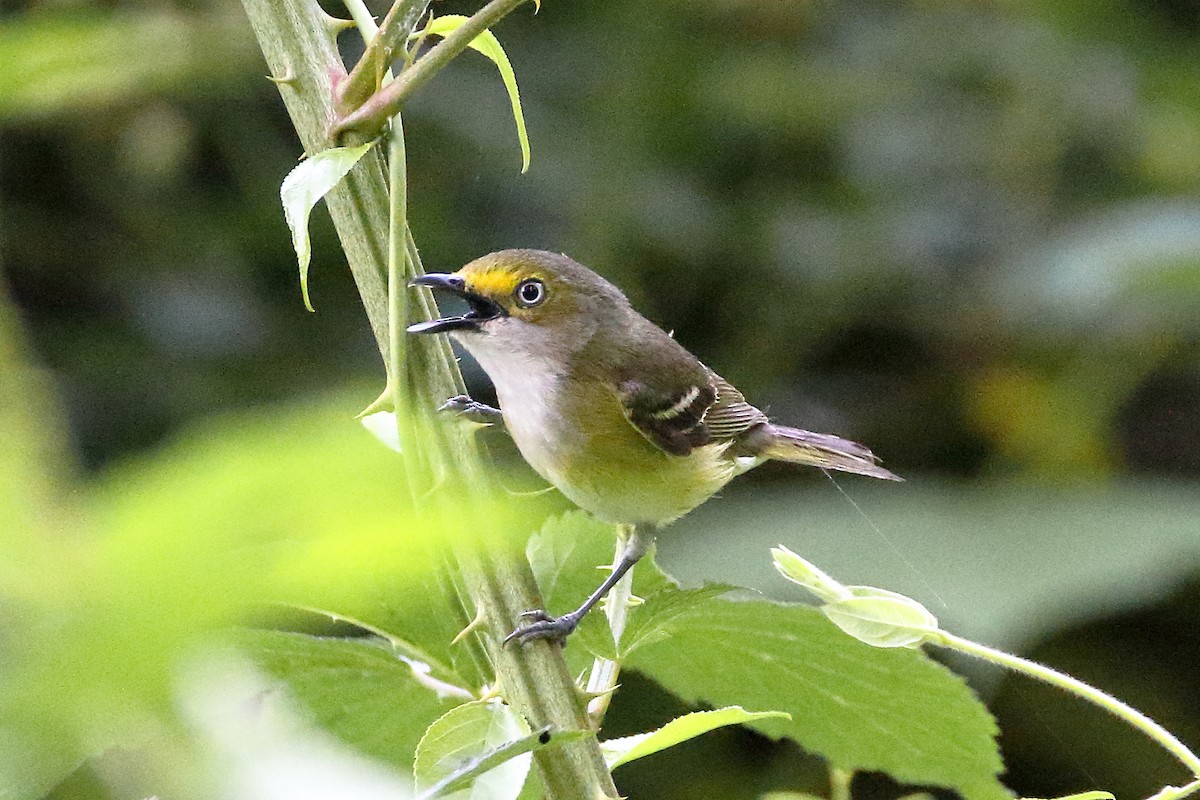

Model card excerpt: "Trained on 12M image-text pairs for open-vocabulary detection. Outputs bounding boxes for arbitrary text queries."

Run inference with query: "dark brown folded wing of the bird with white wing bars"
[618,366,767,456]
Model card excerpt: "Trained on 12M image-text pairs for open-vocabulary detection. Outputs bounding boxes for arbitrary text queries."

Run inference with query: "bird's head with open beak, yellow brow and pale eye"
[408,249,629,353]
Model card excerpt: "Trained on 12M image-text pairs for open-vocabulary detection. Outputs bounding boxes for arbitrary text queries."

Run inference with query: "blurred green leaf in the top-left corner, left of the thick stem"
[0,8,262,120]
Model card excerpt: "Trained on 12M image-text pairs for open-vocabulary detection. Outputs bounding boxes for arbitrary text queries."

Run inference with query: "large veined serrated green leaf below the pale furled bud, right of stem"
[626,599,1009,800]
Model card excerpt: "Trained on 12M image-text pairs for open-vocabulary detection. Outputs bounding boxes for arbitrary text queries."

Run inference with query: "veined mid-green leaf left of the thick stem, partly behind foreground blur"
[234,631,462,774]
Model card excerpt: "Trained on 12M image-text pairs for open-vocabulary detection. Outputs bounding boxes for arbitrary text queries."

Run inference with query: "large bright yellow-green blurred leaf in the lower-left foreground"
[0,399,477,789]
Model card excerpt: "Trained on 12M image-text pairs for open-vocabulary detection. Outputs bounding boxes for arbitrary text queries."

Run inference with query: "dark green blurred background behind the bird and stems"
[0,0,1200,798]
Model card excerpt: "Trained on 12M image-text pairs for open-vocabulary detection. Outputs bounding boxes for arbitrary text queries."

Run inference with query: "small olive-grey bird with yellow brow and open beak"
[408,249,900,643]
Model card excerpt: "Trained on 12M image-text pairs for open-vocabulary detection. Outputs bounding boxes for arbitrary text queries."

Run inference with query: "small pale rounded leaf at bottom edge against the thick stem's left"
[413,700,535,800]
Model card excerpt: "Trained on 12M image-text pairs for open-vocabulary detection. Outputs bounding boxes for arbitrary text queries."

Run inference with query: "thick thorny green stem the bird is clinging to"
[242,0,617,800]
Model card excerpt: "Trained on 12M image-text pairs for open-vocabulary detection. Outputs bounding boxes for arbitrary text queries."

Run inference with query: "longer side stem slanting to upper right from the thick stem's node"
[332,0,526,142]
